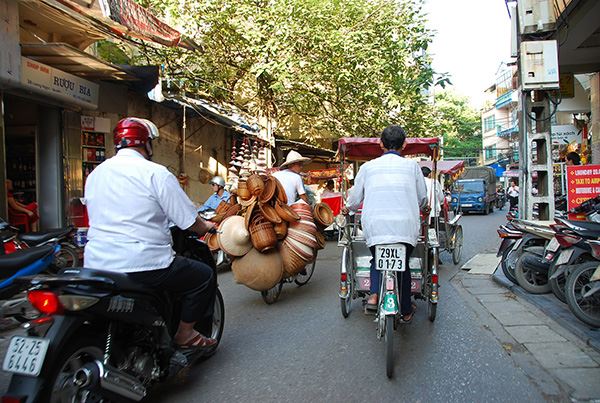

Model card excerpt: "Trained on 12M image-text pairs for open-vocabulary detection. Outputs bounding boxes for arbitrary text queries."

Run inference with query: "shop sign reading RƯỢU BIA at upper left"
[21,56,99,109]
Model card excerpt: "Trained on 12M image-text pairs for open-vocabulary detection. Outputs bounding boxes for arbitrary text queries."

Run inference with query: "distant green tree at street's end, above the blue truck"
[435,91,482,161]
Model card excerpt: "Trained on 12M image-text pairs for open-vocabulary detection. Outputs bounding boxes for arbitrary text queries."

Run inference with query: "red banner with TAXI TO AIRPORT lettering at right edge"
[567,165,600,209]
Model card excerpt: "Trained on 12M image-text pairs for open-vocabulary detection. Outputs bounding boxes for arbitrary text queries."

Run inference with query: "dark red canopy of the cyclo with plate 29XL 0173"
[338,137,440,161]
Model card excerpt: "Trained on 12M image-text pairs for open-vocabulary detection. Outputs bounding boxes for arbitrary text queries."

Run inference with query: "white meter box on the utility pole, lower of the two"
[521,41,560,91]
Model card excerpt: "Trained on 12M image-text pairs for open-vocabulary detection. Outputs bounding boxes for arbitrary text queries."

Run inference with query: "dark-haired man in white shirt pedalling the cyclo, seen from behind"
[342,126,427,323]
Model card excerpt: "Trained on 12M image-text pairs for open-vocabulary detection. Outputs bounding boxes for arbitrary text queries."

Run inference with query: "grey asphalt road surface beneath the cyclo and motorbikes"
[0,212,547,402]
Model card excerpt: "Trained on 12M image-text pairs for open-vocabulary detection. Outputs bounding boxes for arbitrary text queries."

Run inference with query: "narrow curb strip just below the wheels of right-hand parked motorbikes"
[492,271,600,353]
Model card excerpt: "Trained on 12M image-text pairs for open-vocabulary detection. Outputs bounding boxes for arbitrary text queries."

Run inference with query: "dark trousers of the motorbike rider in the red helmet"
[129,256,217,323]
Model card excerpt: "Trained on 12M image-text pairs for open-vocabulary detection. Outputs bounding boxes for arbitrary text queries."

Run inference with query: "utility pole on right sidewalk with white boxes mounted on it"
[511,0,560,220]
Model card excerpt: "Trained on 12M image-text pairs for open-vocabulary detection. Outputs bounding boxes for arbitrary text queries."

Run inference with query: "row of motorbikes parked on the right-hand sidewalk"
[498,196,600,328]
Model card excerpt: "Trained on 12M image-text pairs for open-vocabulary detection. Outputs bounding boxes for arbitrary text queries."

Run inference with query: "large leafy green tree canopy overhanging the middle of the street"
[132,0,434,142]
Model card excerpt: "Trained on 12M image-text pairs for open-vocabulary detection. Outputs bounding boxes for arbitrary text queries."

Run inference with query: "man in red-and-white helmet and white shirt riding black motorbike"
[84,118,216,348]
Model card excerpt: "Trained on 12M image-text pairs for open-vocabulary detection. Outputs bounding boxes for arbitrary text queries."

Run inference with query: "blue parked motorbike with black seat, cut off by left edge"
[0,244,60,322]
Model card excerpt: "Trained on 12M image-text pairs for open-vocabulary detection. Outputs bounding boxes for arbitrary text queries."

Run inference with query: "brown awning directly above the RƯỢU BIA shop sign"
[21,43,138,81]
